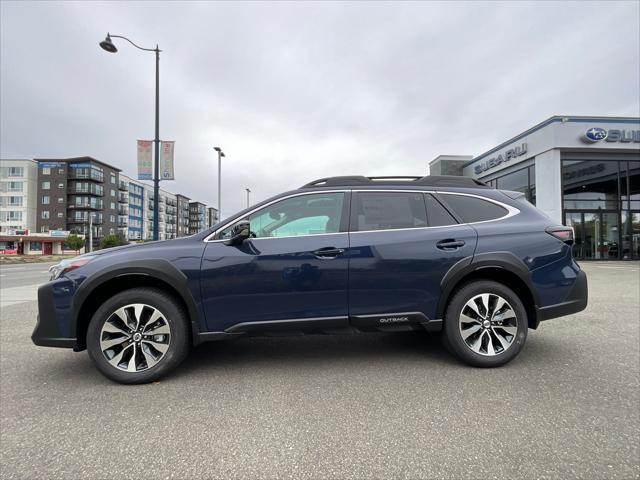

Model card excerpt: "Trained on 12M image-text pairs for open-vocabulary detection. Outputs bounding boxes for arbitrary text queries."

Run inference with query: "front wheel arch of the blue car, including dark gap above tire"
[71,260,201,350]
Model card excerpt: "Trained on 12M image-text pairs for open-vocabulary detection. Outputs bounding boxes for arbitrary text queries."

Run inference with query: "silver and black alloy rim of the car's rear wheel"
[458,293,518,356]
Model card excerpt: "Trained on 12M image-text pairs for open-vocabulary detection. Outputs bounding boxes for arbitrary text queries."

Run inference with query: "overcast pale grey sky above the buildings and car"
[0,1,640,214]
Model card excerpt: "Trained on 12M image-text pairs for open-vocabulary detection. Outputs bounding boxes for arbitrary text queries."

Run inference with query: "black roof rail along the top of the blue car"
[300,175,488,188]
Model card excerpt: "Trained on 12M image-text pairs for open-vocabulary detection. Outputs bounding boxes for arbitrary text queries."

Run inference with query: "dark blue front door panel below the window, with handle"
[201,233,349,331]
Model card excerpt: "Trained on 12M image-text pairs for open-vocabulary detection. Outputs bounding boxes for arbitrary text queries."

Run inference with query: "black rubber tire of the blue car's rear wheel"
[442,280,528,368]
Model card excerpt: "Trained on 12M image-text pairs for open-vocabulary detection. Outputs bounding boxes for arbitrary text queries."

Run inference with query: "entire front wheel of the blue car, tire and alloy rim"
[87,288,190,383]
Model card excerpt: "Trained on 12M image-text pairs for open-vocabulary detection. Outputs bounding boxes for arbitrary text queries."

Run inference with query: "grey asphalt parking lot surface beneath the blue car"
[0,262,640,479]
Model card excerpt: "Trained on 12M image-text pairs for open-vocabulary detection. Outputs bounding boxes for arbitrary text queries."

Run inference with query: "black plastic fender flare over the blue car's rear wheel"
[436,252,540,318]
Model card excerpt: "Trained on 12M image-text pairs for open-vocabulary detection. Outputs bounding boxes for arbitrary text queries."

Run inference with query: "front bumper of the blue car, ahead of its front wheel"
[31,282,77,349]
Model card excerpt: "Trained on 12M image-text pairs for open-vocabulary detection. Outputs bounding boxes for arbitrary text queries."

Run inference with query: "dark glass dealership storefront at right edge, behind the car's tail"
[562,160,640,260]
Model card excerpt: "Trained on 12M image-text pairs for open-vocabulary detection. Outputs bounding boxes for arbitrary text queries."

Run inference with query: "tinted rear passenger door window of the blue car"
[351,192,427,232]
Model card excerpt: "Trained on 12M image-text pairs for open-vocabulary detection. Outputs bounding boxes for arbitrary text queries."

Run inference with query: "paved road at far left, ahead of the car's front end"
[0,262,56,307]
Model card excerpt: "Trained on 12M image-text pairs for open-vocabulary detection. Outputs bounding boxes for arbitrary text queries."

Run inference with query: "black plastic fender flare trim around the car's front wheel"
[71,258,200,339]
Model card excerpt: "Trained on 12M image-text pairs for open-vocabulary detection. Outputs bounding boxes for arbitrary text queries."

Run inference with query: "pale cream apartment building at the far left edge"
[0,159,38,233]
